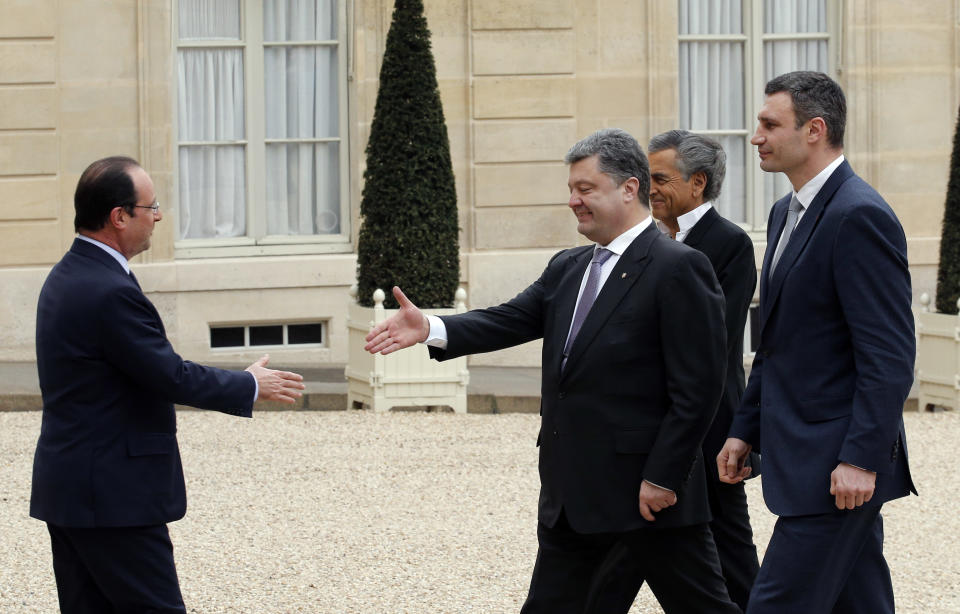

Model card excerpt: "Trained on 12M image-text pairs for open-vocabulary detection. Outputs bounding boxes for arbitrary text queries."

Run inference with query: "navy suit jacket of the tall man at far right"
[730,162,916,516]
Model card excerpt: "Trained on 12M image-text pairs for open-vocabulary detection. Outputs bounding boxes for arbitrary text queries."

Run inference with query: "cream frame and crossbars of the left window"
[169,0,353,258]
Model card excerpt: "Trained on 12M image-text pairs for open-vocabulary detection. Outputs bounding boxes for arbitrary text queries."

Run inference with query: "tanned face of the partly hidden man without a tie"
[648,149,706,231]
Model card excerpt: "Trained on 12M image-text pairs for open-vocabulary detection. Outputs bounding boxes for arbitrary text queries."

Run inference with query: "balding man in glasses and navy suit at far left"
[30,157,303,614]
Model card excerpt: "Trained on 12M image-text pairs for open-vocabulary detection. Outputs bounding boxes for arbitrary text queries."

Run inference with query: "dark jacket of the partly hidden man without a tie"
[684,208,759,512]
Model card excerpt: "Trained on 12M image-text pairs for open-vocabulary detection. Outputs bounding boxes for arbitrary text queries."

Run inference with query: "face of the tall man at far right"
[750,92,810,177]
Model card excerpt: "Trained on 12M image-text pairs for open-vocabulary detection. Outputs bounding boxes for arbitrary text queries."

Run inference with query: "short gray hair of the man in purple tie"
[563,128,650,206]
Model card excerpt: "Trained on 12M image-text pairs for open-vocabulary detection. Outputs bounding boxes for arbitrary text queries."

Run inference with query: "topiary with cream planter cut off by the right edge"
[916,104,960,409]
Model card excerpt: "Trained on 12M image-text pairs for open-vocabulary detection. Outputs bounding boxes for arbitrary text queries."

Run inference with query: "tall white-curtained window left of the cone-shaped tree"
[176,0,348,255]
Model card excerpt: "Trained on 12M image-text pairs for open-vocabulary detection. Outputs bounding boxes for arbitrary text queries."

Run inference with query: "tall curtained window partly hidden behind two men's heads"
[679,0,831,229]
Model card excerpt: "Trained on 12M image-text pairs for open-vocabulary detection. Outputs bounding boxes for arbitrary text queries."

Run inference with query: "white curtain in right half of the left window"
[263,0,340,235]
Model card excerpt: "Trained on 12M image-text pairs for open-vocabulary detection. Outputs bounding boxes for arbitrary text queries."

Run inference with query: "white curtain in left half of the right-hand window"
[679,0,747,222]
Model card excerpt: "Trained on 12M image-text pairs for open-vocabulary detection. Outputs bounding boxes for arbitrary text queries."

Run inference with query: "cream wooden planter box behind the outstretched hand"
[345,287,470,413]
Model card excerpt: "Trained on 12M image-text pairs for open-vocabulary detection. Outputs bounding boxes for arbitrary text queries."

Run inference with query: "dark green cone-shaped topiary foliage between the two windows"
[357,0,460,308]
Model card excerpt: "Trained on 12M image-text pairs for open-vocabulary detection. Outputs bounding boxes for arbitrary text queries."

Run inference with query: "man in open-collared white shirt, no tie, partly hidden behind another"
[596,130,760,614]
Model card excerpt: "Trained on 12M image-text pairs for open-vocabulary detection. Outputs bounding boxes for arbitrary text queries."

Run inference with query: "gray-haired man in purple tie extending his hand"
[366,130,739,614]
